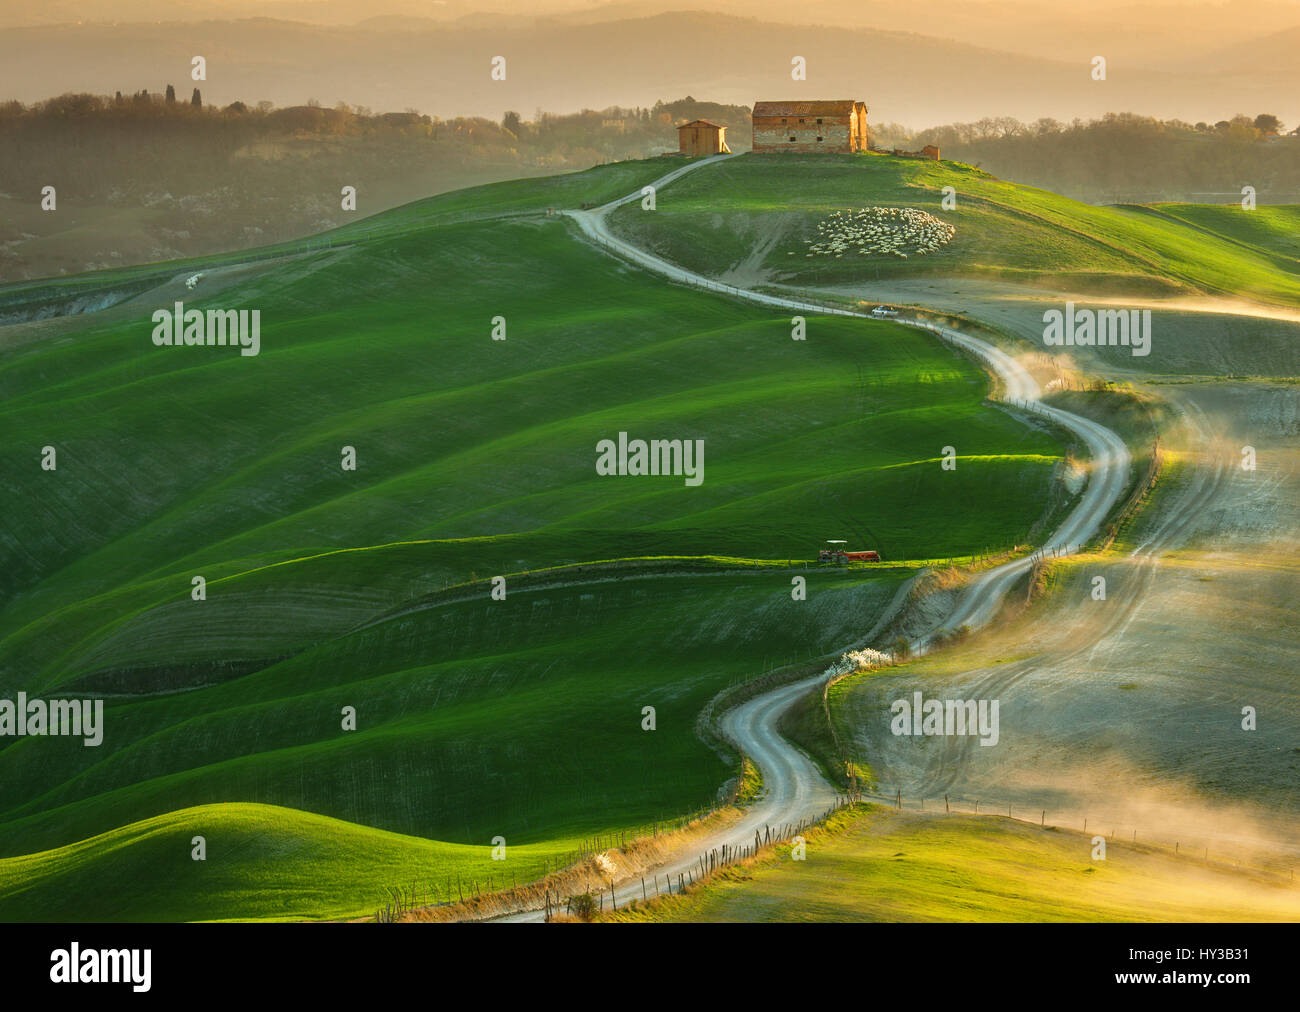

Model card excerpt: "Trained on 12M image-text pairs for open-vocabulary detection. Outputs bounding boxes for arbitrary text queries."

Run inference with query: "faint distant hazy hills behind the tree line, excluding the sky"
[0,13,1300,126]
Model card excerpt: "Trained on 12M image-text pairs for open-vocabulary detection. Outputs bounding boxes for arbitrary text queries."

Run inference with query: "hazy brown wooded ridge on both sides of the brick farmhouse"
[0,87,1300,280]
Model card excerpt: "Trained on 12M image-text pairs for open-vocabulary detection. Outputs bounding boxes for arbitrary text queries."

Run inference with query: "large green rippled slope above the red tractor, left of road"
[0,210,1058,686]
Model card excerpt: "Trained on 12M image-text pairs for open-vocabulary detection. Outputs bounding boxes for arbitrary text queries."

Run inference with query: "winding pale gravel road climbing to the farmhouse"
[498,155,1130,921]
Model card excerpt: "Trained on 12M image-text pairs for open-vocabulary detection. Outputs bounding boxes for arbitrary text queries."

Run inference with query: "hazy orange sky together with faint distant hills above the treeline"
[0,0,1300,127]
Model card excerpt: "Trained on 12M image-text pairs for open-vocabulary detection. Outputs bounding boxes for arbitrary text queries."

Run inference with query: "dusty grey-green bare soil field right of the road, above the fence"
[839,382,1300,864]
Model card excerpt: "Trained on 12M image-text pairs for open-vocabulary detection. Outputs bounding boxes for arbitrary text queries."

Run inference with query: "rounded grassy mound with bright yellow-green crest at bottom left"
[0,804,504,922]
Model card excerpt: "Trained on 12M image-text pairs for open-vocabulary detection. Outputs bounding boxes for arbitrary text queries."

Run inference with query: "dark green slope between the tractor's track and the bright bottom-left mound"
[0,570,905,855]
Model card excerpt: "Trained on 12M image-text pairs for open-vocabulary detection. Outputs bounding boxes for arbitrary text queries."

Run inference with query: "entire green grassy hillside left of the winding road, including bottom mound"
[0,155,1076,920]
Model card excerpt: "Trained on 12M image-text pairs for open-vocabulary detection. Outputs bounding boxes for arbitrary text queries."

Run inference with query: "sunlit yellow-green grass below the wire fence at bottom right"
[605,805,1300,922]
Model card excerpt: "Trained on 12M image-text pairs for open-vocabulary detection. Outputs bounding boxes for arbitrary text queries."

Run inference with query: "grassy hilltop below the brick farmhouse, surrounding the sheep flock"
[614,155,1300,306]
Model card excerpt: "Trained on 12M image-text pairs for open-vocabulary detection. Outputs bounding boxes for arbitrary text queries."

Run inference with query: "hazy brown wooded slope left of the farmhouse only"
[0,86,749,281]
